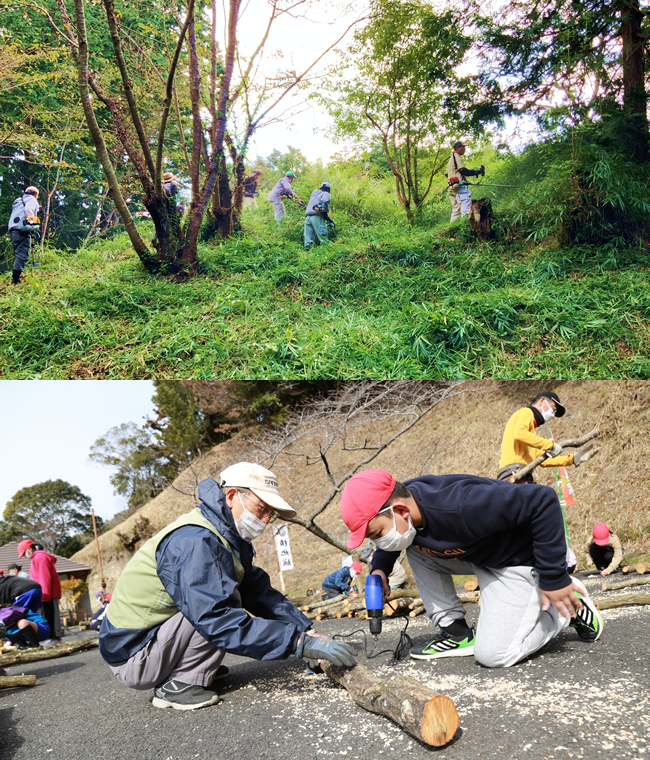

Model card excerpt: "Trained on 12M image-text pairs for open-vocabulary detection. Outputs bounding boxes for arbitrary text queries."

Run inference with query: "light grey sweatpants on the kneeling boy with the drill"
[406,546,571,668]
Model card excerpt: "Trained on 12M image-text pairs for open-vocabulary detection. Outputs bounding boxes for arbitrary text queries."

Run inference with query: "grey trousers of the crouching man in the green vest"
[110,612,226,690]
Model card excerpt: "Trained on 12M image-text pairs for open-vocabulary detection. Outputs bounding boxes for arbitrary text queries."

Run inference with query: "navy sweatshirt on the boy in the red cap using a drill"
[372,475,571,591]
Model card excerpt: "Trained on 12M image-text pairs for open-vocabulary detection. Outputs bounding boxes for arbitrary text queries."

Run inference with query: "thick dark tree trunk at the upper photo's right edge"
[619,0,650,164]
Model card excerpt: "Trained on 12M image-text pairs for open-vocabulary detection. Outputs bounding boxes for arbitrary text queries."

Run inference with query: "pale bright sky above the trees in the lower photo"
[0,380,154,519]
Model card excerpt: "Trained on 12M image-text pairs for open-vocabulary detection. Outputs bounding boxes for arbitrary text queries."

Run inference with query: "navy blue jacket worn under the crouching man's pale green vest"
[100,478,311,664]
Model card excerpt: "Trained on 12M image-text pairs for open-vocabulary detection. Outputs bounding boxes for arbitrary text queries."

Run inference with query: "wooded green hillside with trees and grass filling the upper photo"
[0,0,650,378]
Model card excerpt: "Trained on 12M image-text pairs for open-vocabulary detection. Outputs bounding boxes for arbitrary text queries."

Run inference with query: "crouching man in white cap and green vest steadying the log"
[99,462,356,710]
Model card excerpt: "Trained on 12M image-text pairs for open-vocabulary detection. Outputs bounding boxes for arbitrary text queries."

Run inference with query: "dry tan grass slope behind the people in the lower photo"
[73,381,650,597]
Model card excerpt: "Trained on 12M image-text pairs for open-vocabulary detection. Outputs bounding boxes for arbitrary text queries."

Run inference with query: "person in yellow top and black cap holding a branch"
[497,391,598,483]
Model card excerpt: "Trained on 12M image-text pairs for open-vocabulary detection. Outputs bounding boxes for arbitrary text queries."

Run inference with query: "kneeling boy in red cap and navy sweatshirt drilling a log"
[341,470,603,668]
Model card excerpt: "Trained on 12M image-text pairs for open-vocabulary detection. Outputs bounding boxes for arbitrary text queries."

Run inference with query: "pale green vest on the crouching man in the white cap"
[106,507,244,628]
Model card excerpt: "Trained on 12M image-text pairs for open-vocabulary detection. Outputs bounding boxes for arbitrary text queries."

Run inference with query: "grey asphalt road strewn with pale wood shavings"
[0,582,650,760]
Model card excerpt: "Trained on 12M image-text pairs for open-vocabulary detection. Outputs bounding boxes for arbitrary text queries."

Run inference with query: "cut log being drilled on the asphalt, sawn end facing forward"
[321,661,459,747]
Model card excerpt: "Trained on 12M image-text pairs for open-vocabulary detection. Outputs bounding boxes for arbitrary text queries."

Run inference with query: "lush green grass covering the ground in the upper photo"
[0,201,650,379]
